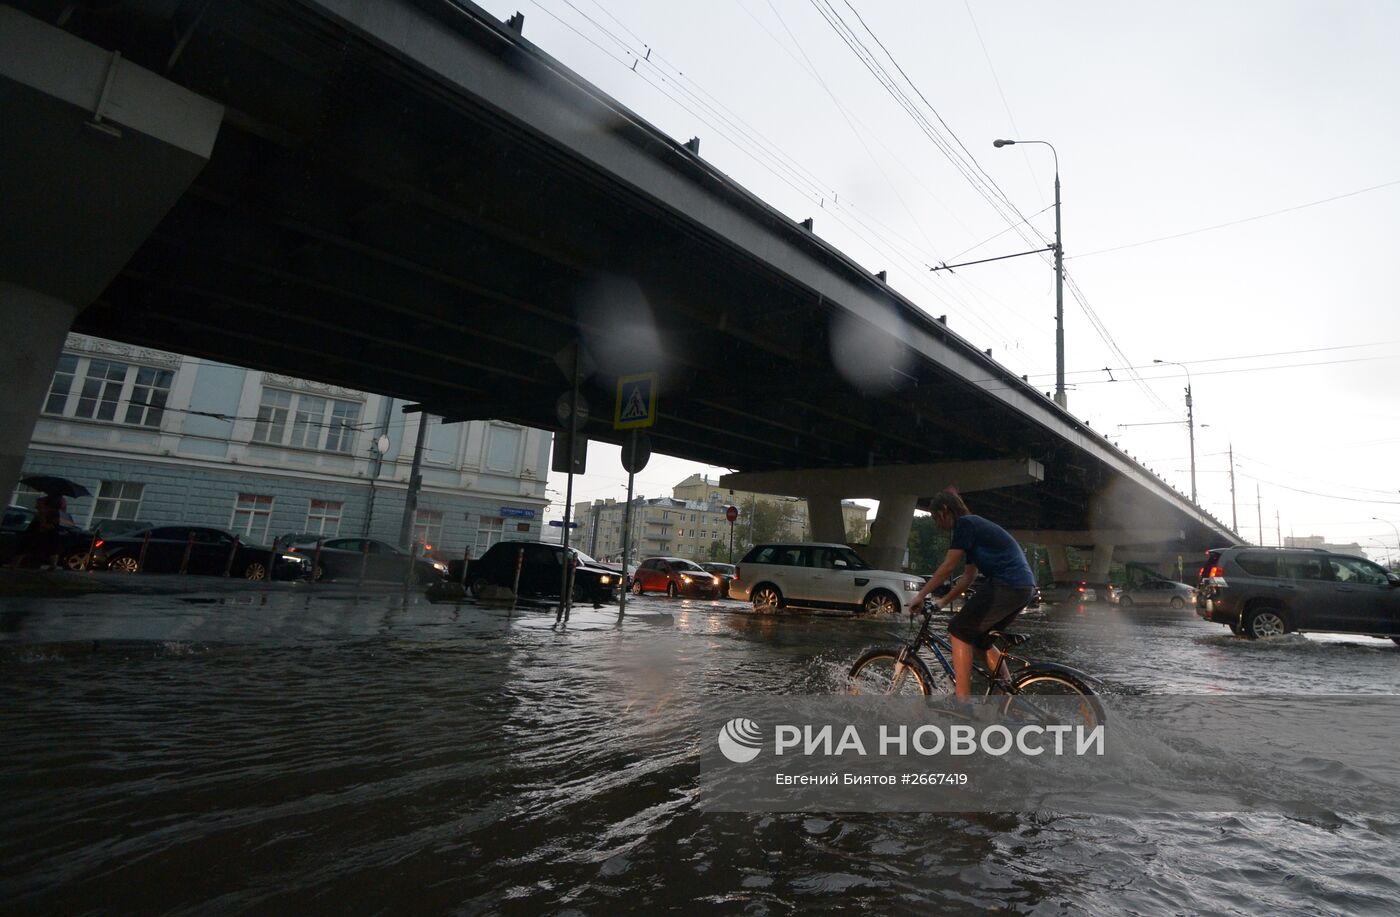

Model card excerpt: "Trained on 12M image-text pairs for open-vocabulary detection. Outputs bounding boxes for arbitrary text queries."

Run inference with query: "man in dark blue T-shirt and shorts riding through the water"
[909,490,1036,697]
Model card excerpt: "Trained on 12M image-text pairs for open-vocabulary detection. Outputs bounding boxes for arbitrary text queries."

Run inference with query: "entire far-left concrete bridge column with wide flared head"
[0,6,224,497]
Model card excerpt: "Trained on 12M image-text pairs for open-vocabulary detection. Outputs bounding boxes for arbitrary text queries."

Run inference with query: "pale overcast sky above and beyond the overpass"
[483,0,1400,559]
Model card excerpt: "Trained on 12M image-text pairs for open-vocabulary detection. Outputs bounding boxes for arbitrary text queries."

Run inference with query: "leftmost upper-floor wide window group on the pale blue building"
[43,353,175,427]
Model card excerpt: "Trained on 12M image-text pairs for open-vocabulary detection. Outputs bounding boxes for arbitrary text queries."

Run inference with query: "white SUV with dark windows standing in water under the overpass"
[729,542,924,615]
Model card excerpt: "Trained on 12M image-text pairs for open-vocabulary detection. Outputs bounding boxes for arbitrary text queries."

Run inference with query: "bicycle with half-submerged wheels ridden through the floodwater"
[848,598,1103,724]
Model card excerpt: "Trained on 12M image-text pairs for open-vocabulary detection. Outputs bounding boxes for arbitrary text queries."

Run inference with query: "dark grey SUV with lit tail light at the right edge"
[1196,547,1400,643]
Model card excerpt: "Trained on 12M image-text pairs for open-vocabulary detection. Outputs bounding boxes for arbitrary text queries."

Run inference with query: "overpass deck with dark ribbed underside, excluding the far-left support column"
[5,0,1237,551]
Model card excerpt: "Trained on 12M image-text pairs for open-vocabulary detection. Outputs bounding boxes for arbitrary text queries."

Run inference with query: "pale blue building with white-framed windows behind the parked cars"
[11,335,552,556]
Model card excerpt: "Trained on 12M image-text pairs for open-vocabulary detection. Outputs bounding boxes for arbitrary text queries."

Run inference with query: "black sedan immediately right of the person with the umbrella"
[97,525,311,581]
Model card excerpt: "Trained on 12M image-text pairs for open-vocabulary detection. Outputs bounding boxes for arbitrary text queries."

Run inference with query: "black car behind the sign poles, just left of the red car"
[448,542,622,605]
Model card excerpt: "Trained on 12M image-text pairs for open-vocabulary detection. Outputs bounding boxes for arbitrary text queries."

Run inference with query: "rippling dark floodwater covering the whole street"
[0,589,1400,914]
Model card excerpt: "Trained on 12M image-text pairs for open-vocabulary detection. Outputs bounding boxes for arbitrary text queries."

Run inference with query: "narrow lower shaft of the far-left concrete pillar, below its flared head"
[0,281,78,500]
